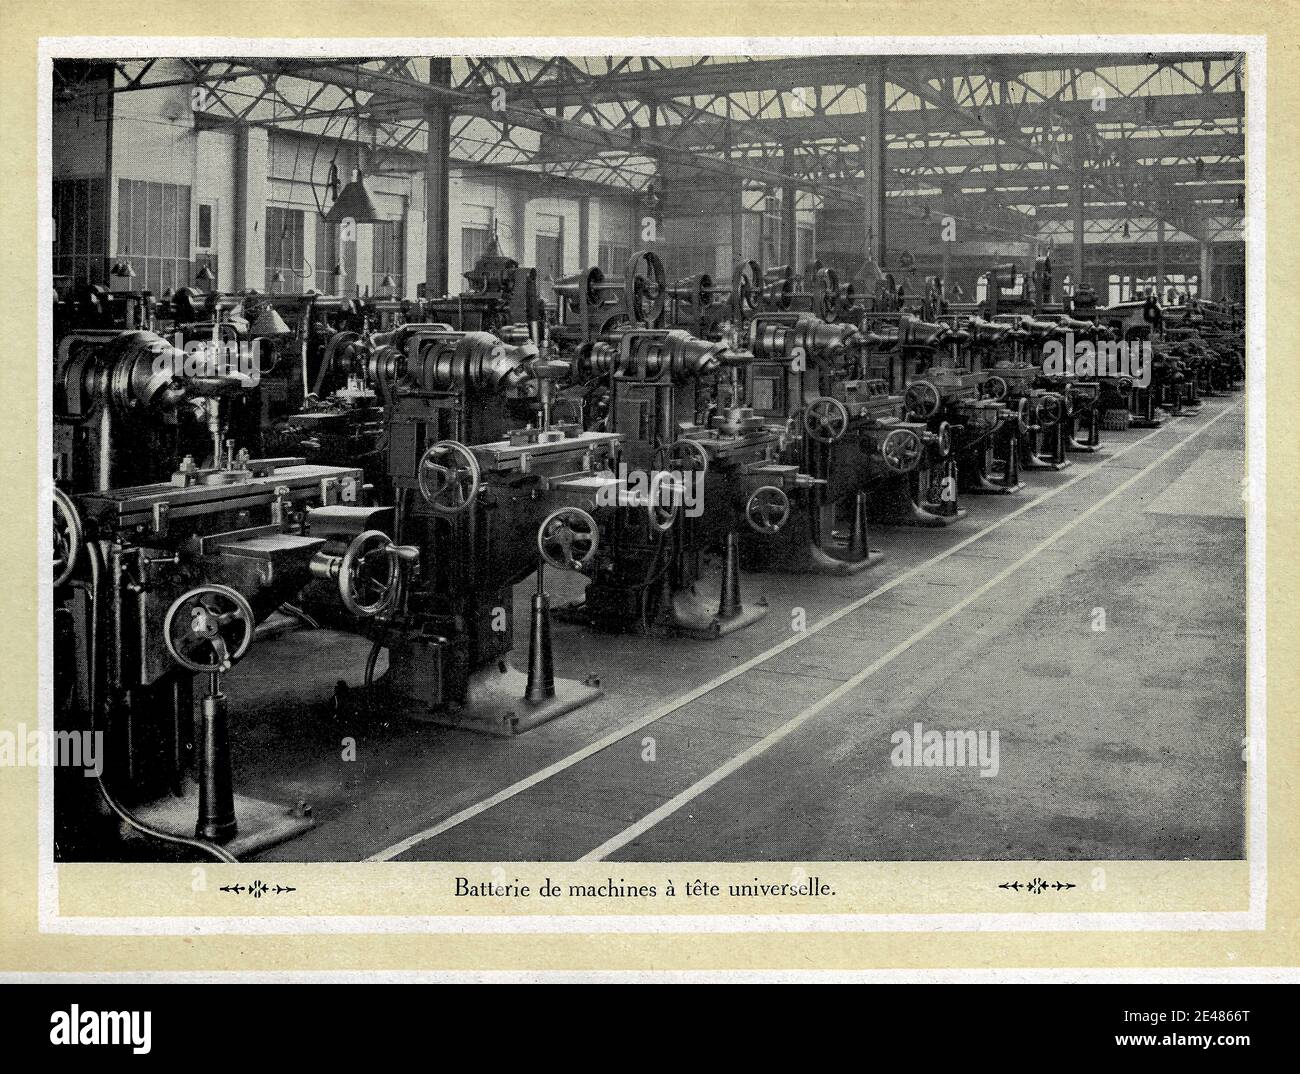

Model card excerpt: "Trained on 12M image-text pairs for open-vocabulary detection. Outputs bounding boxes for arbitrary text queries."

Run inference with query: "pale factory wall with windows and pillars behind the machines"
[53,70,815,298]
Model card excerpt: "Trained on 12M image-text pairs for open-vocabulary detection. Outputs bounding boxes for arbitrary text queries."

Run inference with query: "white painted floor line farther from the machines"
[579,406,1236,862]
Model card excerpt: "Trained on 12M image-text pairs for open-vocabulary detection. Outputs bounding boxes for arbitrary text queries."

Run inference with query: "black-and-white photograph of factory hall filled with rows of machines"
[48,52,1253,862]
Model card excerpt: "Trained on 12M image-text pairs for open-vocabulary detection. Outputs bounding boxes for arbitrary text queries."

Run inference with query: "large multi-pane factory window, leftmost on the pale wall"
[117,179,194,294]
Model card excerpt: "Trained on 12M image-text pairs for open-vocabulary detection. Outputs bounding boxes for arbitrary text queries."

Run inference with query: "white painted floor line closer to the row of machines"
[364,407,1190,862]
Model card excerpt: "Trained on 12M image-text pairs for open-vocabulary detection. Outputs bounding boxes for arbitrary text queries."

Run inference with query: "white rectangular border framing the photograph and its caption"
[35,34,1268,930]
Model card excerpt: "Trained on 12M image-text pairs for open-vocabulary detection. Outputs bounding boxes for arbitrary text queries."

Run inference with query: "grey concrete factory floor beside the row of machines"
[226,395,1245,861]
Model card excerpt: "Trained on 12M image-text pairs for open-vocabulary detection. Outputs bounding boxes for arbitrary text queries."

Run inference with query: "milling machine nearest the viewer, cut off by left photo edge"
[53,322,417,861]
